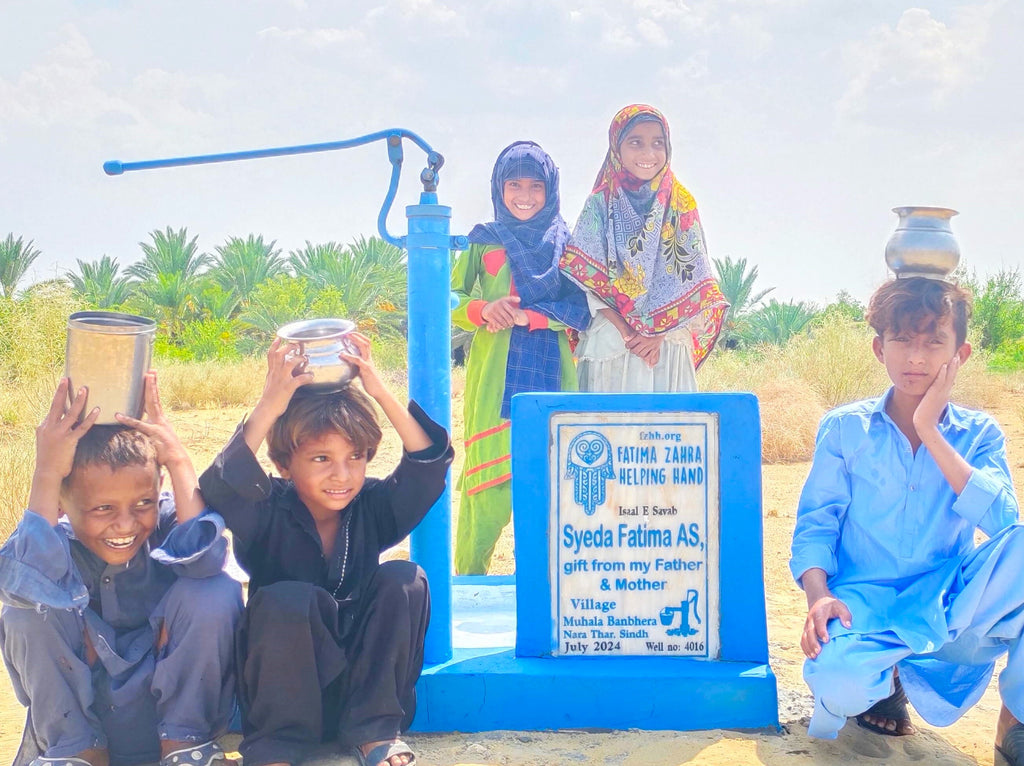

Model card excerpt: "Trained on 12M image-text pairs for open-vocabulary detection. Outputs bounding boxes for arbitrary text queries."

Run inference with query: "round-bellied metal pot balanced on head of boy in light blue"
[886,207,959,280]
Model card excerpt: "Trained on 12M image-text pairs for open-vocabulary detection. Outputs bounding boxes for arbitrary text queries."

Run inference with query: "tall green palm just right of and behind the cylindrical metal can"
[125,226,212,337]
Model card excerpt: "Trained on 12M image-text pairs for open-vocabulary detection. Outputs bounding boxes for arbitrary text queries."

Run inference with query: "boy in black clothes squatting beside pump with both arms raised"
[200,333,453,766]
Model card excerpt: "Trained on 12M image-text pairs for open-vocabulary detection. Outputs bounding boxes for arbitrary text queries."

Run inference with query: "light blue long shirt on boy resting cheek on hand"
[790,390,1018,653]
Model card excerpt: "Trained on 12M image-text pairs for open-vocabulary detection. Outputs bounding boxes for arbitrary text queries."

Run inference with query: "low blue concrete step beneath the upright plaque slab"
[413,649,778,731]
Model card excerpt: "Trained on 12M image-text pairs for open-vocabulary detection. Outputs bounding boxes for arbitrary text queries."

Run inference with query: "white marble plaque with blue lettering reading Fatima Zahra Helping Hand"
[549,412,719,658]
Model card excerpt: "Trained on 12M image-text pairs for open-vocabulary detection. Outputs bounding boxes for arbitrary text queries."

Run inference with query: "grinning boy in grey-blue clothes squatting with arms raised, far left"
[0,373,242,766]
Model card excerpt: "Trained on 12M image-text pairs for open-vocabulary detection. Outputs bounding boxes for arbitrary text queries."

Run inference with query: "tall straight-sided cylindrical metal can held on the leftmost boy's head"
[65,311,157,424]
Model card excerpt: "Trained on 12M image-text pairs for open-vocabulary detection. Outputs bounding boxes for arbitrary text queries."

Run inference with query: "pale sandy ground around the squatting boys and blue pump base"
[0,401,1024,766]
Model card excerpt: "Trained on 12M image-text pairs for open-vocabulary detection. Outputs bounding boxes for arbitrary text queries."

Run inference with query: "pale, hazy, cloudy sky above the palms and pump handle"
[0,0,1024,304]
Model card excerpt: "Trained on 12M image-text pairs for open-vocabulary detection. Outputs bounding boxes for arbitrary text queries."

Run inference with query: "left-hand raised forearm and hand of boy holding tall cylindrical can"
[29,378,99,526]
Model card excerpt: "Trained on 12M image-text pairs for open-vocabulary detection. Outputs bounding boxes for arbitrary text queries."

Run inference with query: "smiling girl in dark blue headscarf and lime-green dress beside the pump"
[452,141,590,575]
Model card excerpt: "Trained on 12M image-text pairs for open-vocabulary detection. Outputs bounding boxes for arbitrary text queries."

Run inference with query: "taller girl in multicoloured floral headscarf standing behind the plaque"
[561,104,728,391]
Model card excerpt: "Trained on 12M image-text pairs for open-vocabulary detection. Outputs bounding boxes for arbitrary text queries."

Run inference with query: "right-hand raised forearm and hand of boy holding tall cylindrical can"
[114,370,206,524]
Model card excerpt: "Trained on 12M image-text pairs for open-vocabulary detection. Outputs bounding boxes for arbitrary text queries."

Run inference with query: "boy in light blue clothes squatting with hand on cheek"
[791,278,1024,764]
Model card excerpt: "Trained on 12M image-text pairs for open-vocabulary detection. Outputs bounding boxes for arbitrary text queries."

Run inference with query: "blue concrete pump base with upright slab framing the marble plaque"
[413,393,778,732]
